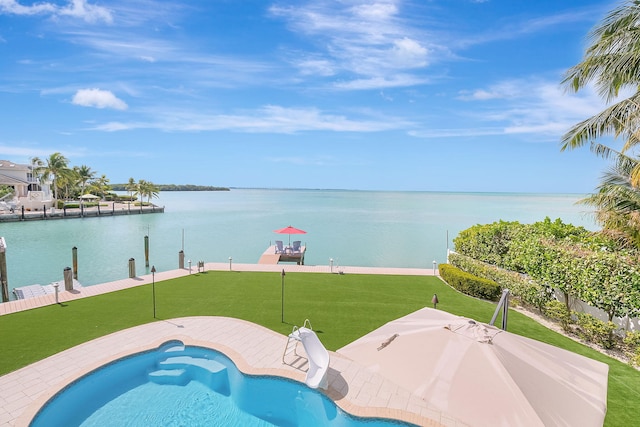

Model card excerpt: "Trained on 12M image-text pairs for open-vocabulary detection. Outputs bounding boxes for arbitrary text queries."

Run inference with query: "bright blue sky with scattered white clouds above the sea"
[0,0,617,193]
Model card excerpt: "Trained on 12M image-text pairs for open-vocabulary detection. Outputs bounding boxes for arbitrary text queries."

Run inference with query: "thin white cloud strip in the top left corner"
[0,0,113,23]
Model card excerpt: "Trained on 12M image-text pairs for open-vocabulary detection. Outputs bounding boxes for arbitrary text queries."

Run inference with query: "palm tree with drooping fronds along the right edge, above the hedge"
[561,0,640,244]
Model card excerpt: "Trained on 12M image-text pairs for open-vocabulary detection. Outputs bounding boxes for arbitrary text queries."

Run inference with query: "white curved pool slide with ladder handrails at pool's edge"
[282,319,329,388]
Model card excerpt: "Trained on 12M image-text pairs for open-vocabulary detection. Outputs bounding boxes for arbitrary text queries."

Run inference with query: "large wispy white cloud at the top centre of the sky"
[270,0,438,89]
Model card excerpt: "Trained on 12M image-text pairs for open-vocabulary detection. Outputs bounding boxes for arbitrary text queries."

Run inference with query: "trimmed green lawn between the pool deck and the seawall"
[0,271,640,427]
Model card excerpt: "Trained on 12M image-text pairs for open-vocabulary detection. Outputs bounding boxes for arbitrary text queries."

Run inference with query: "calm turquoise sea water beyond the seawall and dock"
[0,189,596,298]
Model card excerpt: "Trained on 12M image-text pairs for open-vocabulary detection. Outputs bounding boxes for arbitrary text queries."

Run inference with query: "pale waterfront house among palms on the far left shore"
[0,160,53,211]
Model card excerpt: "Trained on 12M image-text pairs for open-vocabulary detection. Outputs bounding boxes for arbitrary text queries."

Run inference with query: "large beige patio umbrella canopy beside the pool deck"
[338,308,609,426]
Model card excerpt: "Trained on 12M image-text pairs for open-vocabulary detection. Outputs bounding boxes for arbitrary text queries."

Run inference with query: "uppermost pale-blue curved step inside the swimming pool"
[159,356,230,396]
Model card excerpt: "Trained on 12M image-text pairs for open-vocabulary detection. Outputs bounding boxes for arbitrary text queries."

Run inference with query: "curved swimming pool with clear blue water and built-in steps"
[31,341,413,427]
